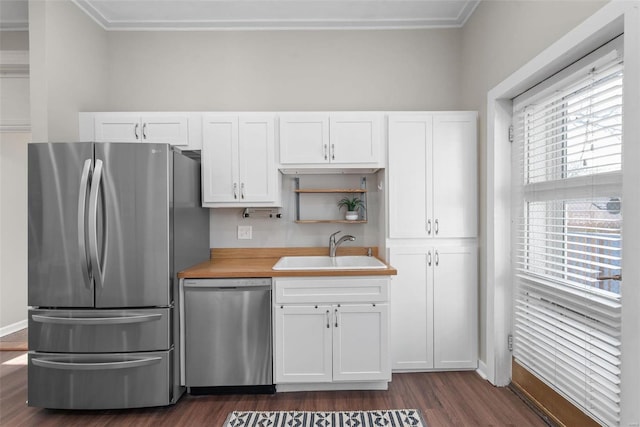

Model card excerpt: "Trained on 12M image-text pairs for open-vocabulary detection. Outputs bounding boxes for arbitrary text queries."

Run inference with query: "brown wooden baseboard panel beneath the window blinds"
[511,359,600,427]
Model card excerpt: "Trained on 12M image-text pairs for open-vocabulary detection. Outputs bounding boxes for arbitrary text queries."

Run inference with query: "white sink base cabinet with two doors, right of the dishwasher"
[273,276,391,388]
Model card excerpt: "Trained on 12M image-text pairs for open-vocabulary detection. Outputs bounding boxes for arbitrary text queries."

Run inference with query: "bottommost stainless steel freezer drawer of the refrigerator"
[28,350,173,409]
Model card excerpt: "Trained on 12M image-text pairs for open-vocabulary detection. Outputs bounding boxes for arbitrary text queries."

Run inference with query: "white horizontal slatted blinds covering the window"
[512,40,623,426]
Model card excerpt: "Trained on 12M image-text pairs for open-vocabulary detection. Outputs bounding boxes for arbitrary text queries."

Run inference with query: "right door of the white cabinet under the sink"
[333,304,391,381]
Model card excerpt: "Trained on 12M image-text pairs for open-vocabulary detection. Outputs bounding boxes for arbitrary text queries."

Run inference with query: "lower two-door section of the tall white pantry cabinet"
[389,245,478,371]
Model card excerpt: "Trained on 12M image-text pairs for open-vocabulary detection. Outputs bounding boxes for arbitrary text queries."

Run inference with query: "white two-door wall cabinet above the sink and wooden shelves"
[280,112,384,168]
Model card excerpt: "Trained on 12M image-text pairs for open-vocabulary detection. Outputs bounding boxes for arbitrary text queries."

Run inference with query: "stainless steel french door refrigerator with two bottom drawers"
[28,143,209,409]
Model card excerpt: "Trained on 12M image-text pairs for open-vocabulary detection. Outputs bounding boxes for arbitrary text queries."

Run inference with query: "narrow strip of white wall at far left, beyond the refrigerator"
[0,31,31,336]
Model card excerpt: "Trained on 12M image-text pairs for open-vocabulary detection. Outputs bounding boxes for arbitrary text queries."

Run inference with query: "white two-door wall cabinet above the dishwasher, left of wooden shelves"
[202,114,280,207]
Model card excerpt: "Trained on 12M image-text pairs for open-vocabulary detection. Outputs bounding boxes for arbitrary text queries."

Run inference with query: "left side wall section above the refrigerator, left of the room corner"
[29,0,109,142]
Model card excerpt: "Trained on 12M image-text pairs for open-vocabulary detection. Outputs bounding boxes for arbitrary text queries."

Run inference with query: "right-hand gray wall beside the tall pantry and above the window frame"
[460,0,607,368]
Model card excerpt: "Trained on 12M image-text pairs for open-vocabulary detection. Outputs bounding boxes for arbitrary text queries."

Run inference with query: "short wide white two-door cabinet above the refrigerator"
[80,112,201,150]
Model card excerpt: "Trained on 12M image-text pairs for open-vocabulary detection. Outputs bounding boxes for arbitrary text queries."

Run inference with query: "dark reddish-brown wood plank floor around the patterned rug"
[0,356,547,427]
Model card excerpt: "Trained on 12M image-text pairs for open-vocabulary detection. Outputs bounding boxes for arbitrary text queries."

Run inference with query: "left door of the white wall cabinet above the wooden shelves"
[280,114,329,164]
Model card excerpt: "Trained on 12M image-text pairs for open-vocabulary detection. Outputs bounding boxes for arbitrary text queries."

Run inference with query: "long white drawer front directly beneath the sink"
[274,276,389,304]
